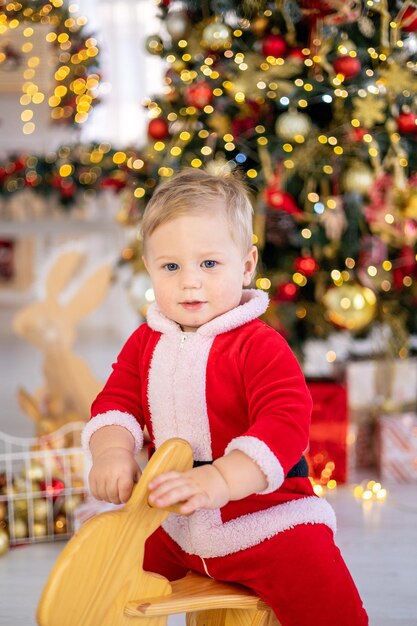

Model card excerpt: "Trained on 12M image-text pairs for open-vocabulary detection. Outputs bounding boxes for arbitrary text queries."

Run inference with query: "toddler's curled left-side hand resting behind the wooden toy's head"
[88,447,141,504]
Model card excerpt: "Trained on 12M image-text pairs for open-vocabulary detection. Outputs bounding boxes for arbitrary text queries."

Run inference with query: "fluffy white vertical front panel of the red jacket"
[148,332,214,461]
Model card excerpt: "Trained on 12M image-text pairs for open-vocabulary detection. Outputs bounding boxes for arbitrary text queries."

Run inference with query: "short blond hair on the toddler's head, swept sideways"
[141,168,253,254]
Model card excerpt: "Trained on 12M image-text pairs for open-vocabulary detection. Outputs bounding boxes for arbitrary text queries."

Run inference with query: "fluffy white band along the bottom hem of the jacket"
[162,496,336,559]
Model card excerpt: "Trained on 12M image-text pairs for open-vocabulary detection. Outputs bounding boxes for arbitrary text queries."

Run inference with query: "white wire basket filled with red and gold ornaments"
[0,422,87,546]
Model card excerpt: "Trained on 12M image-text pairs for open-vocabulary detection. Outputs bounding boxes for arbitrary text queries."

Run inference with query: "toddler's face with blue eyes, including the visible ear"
[145,209,257,332]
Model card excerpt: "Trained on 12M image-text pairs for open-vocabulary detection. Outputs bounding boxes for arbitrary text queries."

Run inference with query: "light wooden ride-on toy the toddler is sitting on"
[37,439,279,626]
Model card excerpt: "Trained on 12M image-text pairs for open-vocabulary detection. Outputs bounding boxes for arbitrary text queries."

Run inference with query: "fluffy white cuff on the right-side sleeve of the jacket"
[224,436,284,495]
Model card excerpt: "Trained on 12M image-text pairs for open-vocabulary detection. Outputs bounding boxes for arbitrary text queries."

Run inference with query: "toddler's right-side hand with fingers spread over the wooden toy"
[148,465,230,515]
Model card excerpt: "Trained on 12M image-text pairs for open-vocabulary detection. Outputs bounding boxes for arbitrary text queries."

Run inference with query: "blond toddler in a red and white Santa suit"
[83,169,368,626]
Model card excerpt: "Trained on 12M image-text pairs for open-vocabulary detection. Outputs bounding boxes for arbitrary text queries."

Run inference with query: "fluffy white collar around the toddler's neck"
[146,289,269,337]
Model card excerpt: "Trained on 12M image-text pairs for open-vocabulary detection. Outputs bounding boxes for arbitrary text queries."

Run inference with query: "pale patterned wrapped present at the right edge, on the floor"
[378,413,417,483]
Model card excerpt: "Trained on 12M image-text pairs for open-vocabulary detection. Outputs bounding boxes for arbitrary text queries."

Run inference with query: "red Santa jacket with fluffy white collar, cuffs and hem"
[84,290,335,558]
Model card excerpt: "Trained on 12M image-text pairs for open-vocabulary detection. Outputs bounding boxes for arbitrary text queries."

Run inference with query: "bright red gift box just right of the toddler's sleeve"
[306,381,348,484]
